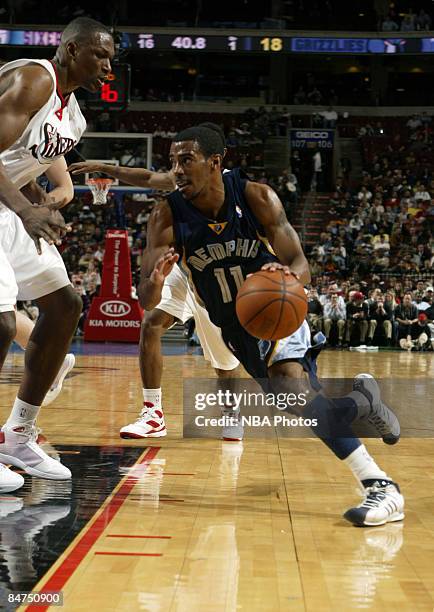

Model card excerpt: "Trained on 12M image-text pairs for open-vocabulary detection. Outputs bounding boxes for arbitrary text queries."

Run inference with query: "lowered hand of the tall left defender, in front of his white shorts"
[20,206,68,255]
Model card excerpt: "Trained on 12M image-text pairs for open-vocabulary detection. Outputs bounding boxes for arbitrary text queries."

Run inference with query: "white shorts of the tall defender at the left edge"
[0,204,71,312]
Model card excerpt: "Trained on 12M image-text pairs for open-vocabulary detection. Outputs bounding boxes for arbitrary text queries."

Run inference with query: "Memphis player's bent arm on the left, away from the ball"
[138,201,179,310]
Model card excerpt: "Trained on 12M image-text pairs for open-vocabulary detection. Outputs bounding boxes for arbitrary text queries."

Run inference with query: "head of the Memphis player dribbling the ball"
[170,126,225,200]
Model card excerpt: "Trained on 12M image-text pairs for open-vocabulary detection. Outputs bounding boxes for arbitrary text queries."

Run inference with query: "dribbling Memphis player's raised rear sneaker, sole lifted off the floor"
[349,374,401,444]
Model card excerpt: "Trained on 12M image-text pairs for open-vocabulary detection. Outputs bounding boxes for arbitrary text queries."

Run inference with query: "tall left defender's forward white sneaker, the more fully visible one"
[0,423,72,480]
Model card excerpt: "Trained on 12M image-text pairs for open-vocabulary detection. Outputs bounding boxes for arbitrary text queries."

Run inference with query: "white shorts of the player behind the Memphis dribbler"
[156,265,239,370]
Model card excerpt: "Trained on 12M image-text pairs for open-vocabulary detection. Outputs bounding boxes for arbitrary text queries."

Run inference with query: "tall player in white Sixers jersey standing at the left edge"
[0,18,114,492]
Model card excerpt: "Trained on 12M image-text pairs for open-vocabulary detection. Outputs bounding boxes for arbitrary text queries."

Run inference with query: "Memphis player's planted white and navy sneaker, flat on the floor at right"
[344,479,404,527]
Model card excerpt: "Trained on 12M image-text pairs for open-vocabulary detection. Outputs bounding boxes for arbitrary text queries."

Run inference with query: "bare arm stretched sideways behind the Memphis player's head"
[68,162,175,191]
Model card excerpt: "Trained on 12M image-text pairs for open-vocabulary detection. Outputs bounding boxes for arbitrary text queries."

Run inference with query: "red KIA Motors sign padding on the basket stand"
[84,229,143,342]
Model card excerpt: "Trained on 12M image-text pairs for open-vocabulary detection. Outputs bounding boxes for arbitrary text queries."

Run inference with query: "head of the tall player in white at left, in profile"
[56,17,115,93]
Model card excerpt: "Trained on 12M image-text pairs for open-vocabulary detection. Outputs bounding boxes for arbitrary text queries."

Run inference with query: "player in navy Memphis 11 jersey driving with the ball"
[135,128,404,526]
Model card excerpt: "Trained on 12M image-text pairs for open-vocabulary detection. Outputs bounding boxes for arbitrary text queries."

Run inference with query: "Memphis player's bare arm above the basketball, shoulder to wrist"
[245,182,311,285]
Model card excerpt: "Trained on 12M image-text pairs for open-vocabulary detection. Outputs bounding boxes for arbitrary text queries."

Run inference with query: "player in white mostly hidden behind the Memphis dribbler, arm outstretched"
[68,122,243,441]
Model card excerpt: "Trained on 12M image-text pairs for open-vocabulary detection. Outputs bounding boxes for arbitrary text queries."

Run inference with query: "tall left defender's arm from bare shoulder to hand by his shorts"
[0,65,66,253]
